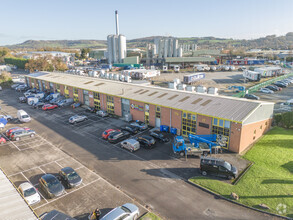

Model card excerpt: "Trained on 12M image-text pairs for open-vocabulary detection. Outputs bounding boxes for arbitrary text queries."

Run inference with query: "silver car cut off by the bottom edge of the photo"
[101,203,139,220]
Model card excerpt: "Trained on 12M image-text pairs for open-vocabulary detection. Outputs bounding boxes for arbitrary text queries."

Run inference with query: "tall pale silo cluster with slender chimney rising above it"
[107,11,127,64]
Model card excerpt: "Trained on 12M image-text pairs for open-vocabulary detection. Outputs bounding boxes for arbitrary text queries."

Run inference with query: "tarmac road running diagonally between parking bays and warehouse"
[1,90,276,220]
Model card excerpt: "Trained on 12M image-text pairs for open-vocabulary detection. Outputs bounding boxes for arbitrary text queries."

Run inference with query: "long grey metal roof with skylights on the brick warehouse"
[28,72,267,122]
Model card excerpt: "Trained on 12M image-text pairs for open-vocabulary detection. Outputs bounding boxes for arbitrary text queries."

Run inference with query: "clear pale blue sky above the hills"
[0,0,293,45]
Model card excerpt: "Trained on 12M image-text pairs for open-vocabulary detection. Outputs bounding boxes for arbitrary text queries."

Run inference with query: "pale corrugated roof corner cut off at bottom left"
[0,169,38,220]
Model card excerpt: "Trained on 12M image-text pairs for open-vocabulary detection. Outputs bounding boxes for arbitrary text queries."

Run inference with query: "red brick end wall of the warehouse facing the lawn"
[238,119,272,153]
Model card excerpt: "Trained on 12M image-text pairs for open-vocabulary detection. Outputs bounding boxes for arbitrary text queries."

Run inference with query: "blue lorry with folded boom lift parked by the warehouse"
[172,134,227,156]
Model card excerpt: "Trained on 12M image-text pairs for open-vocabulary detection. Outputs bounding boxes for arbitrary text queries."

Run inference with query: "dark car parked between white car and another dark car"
[39,174,65,198]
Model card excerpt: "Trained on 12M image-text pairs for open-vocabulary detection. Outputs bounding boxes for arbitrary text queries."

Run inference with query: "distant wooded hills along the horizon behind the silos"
[7,32,293,49]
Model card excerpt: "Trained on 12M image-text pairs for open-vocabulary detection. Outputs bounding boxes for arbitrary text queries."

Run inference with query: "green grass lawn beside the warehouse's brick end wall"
[190,127,293,217]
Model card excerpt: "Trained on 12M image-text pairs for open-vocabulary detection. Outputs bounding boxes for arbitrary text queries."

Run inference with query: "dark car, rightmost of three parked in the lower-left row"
[58,167,82,188]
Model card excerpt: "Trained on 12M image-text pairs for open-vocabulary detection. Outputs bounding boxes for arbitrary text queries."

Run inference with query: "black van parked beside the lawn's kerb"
[200,157,238,179]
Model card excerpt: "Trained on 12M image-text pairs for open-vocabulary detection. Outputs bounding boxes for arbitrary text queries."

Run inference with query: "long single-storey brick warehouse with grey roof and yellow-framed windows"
[26,72,274,153]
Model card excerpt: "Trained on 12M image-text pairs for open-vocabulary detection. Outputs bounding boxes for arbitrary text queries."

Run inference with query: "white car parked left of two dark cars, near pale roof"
[18,182,41,205]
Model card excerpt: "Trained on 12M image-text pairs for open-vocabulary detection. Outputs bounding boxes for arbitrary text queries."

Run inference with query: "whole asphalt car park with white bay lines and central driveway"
[0,90,274,219]
